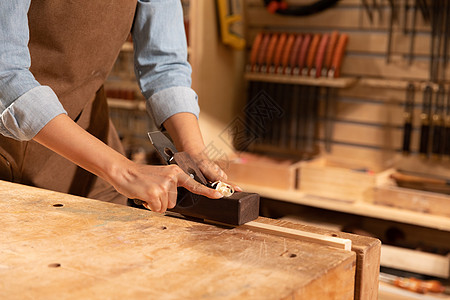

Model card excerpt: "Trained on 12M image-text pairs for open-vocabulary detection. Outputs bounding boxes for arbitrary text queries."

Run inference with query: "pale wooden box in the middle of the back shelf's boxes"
[298,158,376,202]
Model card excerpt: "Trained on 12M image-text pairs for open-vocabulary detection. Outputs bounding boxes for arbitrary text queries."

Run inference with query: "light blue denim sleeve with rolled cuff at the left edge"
[0,0,66,140]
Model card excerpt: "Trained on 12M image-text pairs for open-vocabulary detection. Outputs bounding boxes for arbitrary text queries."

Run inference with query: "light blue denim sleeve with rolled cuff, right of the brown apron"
[132,0,200,126]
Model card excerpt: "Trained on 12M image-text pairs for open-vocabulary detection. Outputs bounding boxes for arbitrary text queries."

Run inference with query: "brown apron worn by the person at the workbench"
[0,0,137,204]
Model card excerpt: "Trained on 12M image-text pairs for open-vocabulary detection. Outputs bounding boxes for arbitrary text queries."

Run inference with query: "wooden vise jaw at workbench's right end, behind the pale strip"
[254,217,381,300]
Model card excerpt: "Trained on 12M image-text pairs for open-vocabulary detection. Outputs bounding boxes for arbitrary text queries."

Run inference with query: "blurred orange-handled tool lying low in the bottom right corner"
[380,273,450,294]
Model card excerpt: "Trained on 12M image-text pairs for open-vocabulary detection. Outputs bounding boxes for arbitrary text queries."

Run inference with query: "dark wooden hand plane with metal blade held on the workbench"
[134,131,259,225]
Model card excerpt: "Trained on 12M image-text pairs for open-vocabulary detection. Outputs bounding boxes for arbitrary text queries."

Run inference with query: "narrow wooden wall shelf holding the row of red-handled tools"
[245,72,358,88]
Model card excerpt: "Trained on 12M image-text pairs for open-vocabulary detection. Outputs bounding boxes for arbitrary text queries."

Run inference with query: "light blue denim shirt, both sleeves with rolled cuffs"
[0,0,199,140]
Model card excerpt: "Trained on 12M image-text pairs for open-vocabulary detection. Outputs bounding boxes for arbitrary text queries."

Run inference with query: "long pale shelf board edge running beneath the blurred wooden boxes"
[238,183,450,231]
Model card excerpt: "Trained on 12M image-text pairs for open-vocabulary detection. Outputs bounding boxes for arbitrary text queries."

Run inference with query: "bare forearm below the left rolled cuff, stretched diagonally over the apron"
[33,114,129,181]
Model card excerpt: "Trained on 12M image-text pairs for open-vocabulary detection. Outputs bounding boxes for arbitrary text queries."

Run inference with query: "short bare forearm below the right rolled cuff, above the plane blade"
[163,113,205,154]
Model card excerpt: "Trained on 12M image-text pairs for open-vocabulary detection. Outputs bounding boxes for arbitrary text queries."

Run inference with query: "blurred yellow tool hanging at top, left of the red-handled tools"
[217,0,245,50]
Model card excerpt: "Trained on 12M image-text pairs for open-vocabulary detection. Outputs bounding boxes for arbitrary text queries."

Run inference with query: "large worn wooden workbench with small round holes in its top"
[0,181,356,300]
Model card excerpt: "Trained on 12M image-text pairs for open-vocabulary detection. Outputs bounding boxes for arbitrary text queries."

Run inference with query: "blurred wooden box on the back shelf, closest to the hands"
[224,153,300,189]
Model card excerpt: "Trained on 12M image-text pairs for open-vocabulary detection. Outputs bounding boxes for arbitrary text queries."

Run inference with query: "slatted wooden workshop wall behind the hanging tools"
[244,0,449,170]
